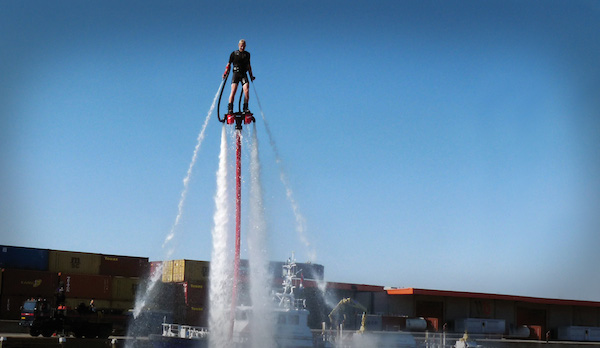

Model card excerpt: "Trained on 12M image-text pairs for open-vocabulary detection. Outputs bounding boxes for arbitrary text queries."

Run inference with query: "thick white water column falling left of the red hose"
[209,125,232,348]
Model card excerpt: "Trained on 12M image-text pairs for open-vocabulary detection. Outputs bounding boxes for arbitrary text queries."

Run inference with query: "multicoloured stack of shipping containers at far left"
[0,246,149,320]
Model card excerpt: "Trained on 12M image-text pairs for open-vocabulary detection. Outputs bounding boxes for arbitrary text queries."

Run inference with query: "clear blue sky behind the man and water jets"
[0,0,600,301]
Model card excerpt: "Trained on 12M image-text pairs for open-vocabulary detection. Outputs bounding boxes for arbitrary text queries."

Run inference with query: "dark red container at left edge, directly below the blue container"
[2,268,58,298]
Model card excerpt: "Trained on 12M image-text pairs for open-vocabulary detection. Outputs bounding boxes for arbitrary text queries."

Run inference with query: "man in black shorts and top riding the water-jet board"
[223,39,255,114]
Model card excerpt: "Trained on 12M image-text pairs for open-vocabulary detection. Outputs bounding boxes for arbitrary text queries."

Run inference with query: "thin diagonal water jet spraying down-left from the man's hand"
[127,81,225,346]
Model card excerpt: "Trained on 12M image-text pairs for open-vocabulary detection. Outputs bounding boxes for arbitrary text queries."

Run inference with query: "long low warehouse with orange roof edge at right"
[379,288,600,341]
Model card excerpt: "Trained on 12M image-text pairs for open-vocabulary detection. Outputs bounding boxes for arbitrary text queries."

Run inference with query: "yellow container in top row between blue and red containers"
[48,250,102,274]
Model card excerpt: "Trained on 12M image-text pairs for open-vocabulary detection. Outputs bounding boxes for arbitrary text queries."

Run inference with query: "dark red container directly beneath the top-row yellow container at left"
[61,274,112,300]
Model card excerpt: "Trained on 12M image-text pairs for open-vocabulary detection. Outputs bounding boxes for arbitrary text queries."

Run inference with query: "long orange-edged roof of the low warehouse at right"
[385,288,600,307]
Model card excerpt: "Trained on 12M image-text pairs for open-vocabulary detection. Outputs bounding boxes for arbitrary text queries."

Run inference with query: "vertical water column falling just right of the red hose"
[248,123,276,348]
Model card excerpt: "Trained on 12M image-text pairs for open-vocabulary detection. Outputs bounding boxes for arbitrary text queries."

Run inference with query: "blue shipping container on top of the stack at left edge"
[0,245,49,271]
